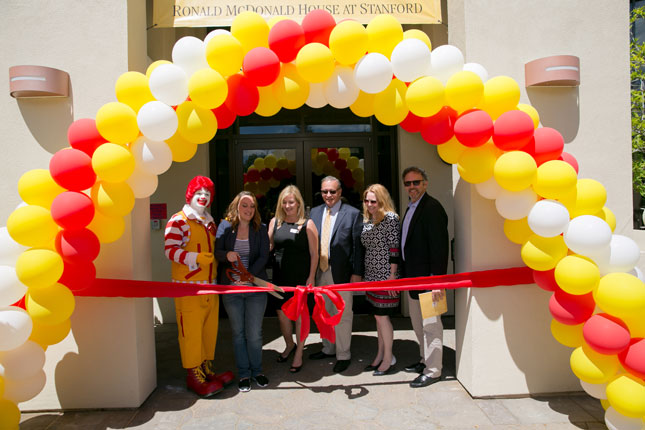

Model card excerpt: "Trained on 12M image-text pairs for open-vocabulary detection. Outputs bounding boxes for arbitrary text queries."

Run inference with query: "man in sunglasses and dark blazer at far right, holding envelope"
[401,166,449,388]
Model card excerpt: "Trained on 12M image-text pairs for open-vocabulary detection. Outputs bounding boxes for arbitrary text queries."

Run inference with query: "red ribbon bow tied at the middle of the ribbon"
[282,285,345,343]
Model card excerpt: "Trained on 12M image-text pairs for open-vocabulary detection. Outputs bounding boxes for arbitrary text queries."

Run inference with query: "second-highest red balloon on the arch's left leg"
[49,148,96,191]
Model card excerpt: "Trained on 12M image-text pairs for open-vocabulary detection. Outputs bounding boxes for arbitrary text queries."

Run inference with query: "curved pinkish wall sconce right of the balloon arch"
[524,55,580,87]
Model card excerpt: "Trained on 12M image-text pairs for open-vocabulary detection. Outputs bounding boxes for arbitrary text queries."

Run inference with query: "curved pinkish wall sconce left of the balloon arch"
[9,66,69,99]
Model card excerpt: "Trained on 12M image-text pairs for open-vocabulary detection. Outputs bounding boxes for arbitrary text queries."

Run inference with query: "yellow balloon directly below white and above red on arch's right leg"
[555,254,600,295]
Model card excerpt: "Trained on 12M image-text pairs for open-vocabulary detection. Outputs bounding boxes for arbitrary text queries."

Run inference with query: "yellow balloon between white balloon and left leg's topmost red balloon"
[96,102,139,145]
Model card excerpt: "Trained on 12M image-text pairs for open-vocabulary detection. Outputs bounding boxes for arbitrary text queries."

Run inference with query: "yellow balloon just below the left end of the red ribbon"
[25,284,75,325]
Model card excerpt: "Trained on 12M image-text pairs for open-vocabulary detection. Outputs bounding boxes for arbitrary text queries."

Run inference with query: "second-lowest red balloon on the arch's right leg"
[582,314,630,355]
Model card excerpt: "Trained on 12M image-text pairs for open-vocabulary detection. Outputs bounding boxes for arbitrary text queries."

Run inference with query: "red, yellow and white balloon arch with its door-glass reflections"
[0,10,645,428]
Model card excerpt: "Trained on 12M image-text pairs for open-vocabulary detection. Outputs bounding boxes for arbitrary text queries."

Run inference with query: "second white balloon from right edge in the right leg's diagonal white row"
[564,215,612,256]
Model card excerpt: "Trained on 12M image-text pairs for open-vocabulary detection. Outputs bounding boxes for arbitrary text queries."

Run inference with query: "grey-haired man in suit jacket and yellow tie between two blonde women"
[309,176,363,373]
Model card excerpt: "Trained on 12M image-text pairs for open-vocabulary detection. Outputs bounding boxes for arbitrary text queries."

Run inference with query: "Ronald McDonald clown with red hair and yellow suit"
[164,176,233,396]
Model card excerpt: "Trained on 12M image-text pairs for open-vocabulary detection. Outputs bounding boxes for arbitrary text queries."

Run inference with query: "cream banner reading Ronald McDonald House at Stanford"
[153,0,442,27]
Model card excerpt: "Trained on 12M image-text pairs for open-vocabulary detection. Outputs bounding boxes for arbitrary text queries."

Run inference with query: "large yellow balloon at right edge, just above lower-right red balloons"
[593,272,645,318]
